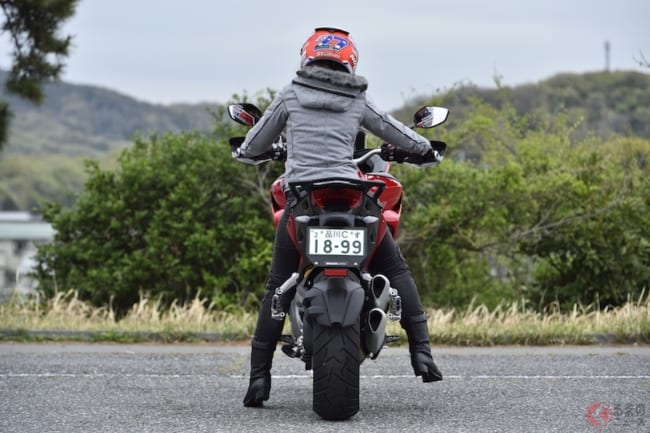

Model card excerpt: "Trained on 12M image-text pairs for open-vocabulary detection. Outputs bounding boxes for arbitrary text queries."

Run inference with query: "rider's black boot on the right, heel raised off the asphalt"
[400,314,442,382]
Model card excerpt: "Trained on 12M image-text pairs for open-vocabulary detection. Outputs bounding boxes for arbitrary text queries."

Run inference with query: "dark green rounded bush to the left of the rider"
[33,129,273,311]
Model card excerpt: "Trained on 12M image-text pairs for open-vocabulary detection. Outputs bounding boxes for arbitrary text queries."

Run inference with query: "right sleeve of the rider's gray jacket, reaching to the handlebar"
[361,97,431,155]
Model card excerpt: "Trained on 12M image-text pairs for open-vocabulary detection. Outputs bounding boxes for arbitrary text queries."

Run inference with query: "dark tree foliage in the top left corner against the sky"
[0,0,78,150]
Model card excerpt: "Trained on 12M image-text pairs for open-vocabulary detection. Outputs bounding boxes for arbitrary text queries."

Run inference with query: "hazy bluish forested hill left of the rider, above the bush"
[0,70,214,156]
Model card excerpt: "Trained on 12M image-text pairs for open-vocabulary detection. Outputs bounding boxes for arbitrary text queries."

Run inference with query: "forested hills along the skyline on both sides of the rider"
[0,71,650,156]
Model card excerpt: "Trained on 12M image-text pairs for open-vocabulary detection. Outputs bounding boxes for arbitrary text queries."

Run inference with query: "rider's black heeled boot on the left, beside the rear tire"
[244,339,276,407]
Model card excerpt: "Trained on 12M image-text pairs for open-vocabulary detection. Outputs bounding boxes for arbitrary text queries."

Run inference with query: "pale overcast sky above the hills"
[0,0,650,110]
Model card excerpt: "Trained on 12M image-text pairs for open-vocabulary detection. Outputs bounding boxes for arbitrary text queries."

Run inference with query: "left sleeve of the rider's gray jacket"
[239,92,288,158]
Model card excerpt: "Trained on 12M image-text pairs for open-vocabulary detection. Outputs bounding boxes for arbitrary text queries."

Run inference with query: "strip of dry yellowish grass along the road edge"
[0,291,650,346]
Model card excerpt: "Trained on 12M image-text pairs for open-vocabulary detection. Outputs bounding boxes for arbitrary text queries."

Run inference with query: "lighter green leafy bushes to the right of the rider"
[397,98,650,307]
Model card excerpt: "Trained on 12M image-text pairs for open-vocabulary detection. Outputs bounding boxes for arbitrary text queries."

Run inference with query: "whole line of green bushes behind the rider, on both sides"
[31,93,650,311]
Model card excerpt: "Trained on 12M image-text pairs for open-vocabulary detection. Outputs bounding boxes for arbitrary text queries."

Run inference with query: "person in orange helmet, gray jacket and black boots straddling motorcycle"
[233,27,442,407]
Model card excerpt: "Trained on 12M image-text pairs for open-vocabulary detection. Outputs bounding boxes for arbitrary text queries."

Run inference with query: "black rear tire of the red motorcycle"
[312,319,361,420]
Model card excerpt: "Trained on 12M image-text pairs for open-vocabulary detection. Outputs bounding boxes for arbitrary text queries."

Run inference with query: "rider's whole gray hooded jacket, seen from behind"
[240,66,431,181]
